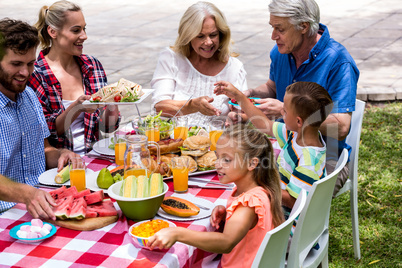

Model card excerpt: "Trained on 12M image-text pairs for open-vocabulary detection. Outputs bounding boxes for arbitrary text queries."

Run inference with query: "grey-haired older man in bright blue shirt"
[240,0,359,196]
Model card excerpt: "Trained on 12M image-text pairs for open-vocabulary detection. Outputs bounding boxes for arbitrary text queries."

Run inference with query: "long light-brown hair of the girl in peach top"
[222,124,284,227]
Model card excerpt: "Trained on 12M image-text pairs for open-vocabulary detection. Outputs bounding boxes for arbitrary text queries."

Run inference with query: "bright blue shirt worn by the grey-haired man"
[269,24,360,160]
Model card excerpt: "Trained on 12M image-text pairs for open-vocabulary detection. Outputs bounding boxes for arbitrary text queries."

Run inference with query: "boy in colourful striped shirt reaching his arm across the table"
[214,81,333,210]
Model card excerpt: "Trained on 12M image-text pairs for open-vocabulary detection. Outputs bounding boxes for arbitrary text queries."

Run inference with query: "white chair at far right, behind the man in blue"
[335,100,366,259]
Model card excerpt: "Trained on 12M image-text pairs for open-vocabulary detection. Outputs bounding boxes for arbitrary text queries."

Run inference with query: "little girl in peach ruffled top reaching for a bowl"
[148,125,283,267]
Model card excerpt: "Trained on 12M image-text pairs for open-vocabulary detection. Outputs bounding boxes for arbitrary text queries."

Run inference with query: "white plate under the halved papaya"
[157,194,215,221]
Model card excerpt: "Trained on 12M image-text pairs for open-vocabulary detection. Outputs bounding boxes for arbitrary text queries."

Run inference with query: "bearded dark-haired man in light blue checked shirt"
[0,19,79,219]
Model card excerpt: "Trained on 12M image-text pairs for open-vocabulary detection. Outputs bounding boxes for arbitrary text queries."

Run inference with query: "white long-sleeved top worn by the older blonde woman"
[151,48,248,126]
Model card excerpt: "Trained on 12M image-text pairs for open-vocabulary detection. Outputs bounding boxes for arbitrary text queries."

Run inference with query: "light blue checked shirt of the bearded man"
[0,87,50,213]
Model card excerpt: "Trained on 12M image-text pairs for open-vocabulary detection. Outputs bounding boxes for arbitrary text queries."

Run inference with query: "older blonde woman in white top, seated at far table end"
[151,2,247,125]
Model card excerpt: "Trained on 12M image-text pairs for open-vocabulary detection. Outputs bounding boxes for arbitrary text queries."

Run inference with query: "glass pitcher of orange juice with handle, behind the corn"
[124,135,160,178]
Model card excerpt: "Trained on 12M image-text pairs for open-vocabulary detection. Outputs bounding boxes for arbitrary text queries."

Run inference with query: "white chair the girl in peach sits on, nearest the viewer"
[251,189,307,268]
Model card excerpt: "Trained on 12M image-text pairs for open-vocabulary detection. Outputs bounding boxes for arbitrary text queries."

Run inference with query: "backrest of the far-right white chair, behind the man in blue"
[346,100,366,183]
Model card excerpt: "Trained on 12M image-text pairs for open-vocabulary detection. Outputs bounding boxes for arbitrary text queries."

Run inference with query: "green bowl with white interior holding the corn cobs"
[108,181,169,221]
